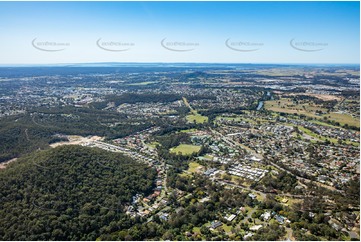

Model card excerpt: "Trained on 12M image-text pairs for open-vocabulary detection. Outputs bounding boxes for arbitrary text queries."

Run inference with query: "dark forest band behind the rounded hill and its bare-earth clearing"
[0,106,153,162]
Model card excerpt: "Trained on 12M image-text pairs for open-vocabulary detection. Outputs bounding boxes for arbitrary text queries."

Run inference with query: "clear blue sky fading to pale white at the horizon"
[0,2,360,64]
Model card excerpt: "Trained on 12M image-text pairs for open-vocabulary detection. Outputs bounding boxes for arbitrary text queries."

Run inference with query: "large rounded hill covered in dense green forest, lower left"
[0,146,156,240]
